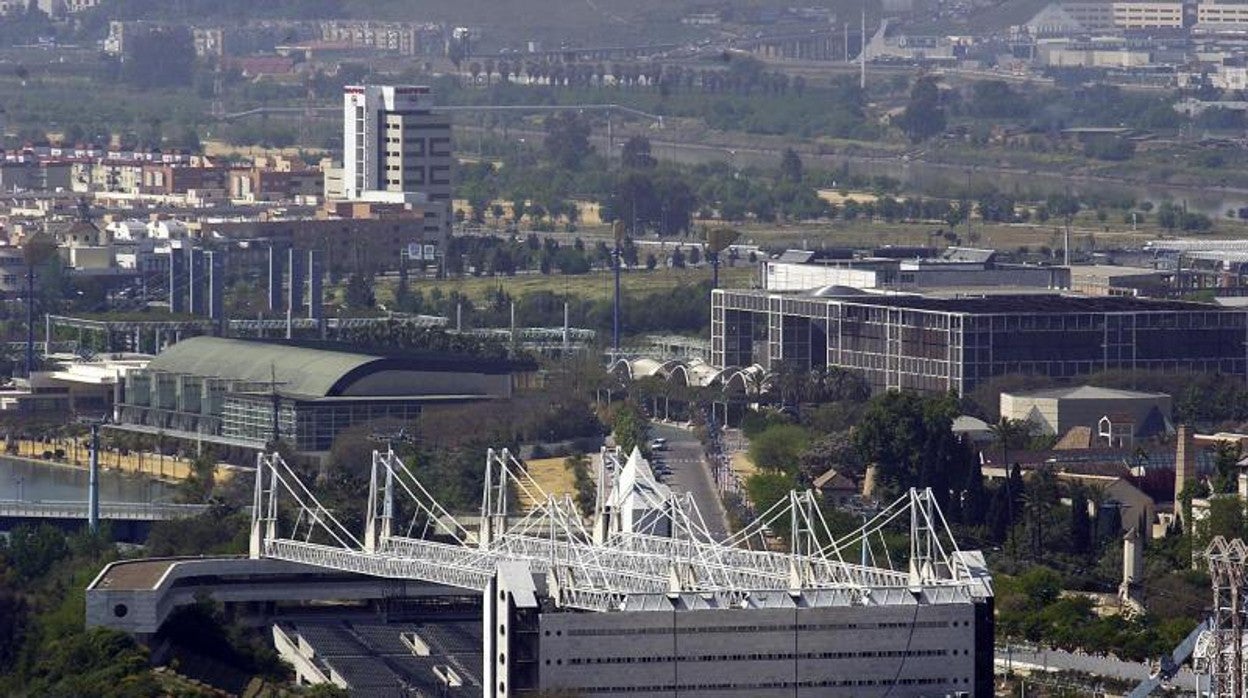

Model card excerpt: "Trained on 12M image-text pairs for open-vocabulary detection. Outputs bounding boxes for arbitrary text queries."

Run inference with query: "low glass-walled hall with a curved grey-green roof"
[116,337,514,452]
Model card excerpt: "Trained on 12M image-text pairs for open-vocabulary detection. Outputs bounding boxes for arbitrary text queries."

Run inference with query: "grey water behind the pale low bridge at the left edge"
[0,457,175,502]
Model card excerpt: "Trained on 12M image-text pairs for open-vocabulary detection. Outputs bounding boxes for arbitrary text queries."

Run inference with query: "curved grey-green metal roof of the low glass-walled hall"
[147,337,388,397]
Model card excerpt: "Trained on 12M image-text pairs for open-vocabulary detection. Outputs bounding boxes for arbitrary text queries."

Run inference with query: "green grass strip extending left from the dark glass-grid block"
[382,263,756,301]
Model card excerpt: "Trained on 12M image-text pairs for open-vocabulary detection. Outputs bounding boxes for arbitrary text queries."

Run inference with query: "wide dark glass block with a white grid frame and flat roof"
[711,287,1248,395]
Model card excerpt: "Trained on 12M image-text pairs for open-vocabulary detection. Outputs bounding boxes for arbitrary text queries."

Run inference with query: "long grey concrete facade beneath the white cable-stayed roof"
[535,592,991,698]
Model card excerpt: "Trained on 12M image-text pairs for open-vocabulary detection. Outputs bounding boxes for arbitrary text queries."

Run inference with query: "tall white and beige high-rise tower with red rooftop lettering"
[342,85,452,243]
